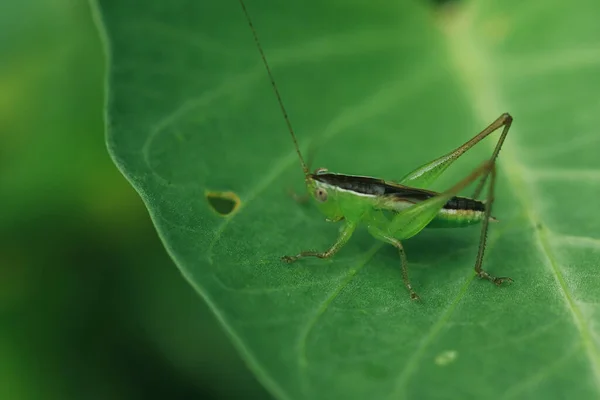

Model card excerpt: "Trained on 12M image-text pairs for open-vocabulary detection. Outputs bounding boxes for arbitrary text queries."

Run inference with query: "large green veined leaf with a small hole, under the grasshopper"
[92,0,600,399]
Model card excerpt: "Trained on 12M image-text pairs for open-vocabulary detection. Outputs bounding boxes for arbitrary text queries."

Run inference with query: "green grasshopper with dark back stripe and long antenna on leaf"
[239,0,512,300]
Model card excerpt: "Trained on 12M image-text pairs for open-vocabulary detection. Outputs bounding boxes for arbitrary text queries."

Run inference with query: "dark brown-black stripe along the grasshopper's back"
[311,173,485,211]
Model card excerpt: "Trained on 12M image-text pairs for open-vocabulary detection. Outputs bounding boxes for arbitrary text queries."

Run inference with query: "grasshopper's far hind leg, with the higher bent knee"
[399,113,512,189]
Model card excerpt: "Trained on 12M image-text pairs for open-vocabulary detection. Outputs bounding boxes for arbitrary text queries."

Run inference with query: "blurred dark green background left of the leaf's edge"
[0,0,269,400]
